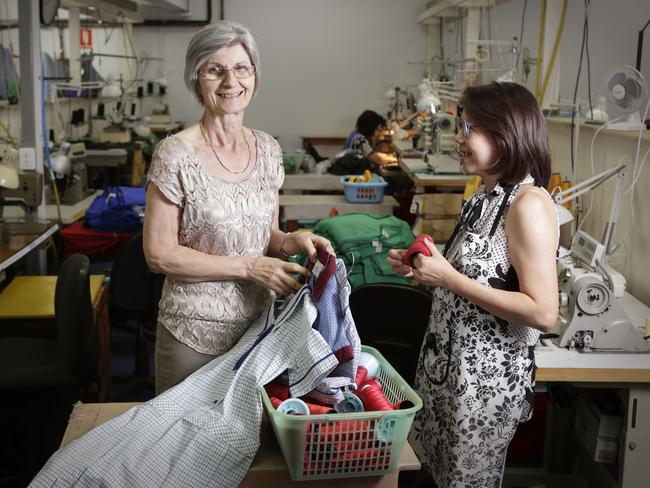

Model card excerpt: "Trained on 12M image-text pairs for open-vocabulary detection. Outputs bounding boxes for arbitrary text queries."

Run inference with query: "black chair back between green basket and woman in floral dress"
[350,283,431,384]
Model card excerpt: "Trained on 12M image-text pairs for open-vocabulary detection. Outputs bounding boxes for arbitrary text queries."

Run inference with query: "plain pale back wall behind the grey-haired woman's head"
[135,0,426,149]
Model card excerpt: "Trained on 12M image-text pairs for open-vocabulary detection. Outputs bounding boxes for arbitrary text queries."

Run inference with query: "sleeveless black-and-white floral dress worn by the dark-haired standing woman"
[410,175,552,488]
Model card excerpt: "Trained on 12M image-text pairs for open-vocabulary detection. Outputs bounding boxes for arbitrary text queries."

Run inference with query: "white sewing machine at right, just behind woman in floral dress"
[557,231,649,353]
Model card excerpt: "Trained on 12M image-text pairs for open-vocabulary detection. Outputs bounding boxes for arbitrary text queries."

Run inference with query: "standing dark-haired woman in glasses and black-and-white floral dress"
[388,83,559,488]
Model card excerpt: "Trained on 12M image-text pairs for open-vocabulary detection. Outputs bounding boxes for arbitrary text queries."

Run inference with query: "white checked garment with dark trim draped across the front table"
[30,286,337,488]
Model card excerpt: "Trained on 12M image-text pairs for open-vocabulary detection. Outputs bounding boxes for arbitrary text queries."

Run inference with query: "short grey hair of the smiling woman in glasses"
[184,20,260,105]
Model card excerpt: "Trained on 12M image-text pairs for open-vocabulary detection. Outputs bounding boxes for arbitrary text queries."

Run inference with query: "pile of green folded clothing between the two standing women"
[314,213,413,288]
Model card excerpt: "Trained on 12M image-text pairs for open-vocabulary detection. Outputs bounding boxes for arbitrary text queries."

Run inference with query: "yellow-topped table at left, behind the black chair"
[0,275,111,402]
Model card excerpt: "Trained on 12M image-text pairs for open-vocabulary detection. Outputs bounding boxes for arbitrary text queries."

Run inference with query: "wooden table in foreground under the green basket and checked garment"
[61,403,420,488]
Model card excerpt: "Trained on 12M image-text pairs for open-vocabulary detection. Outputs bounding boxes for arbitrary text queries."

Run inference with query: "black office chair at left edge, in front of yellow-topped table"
[0,254,99,486]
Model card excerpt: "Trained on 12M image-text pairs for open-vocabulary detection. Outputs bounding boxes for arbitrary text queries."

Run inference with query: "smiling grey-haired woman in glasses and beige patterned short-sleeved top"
[144,21,332,393]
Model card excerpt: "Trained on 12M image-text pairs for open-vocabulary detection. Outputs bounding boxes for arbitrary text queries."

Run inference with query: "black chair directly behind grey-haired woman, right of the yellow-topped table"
[109,234,165,398]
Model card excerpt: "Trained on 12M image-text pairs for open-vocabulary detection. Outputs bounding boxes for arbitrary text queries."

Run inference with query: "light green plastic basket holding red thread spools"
[261,346,422,481]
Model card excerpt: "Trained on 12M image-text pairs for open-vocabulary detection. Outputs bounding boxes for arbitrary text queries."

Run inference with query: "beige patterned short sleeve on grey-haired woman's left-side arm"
[147,137,185,206]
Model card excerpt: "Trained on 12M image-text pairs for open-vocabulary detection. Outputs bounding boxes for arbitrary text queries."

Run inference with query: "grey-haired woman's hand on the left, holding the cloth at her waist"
[247,256,311,295]
